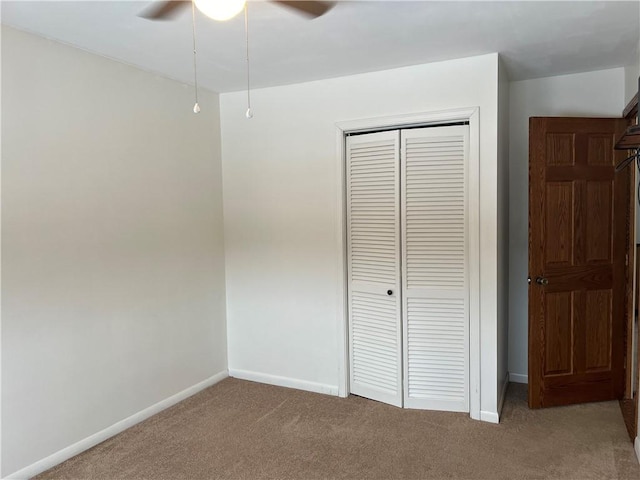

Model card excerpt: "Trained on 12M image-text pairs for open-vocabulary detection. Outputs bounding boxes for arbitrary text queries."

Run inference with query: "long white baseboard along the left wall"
[5,371,229,479]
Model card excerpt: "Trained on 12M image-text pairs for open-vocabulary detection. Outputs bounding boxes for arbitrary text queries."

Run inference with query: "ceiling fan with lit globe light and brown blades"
[140,0,335,21]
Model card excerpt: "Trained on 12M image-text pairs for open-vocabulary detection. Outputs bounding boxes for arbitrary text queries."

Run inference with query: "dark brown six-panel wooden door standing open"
[529,118,629,408]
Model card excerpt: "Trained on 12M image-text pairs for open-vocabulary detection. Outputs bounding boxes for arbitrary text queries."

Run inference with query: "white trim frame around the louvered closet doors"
[335,107,481,420]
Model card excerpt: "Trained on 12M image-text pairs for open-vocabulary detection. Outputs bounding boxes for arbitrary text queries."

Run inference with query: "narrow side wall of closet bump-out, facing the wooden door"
[497,60,509,408]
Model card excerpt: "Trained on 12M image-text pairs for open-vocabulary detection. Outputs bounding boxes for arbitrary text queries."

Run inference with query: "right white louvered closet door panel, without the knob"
[401,126,469,412]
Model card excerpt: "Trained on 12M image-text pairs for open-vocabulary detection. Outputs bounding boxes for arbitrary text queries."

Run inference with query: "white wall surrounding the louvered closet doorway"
[221,54,498,418]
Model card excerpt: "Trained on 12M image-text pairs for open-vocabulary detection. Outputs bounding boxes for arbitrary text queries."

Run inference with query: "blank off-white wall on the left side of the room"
[2,27,226,477]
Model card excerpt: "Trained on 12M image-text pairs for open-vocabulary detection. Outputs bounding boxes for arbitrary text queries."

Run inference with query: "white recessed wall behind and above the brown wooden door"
[509,68,625,382]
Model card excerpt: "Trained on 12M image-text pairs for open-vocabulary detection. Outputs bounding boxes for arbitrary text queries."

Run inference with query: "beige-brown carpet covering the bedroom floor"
[37,379,640,480]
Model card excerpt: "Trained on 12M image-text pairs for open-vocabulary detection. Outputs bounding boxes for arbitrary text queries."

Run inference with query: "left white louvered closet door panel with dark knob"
[346,130,403,406]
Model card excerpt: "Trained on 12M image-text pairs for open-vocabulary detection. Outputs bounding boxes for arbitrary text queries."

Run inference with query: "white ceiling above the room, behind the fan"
[1,0,640,92]
